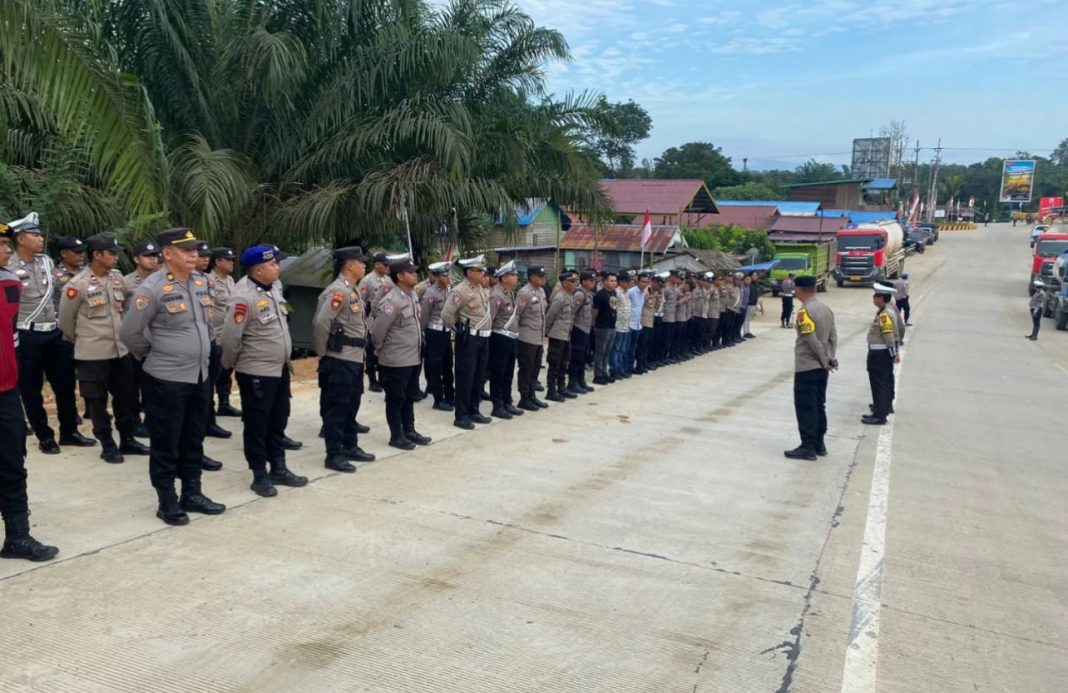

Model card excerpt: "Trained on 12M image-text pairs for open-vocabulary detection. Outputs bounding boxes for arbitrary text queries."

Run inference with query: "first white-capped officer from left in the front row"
[441,255,492,429]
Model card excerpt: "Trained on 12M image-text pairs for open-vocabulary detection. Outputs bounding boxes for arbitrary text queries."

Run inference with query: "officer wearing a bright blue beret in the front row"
[221,246,308,498]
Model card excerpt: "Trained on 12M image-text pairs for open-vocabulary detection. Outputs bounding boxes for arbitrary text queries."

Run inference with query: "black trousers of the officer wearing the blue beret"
[237,365,290,472]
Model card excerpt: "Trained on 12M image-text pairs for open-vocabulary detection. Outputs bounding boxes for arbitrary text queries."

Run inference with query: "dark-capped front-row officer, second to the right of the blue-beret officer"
[373,259,430,450]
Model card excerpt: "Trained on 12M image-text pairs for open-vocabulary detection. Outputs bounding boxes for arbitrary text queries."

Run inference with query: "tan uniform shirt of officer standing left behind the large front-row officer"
[60,267,129,361]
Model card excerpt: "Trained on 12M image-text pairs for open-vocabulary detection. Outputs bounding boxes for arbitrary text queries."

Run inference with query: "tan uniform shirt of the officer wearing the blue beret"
[219,275,293,378]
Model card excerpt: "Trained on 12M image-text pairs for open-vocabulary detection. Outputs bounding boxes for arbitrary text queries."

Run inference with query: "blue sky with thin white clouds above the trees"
[517,0,1068,169]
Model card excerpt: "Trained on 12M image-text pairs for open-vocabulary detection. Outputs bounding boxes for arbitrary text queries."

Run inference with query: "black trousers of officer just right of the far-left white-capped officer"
[75,355,138,447]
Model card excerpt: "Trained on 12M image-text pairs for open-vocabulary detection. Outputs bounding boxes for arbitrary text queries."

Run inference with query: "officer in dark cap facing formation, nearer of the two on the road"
[784,277,838,459]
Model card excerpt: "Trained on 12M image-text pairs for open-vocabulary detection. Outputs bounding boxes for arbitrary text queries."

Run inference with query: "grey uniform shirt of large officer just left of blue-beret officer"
[122,268,211,384]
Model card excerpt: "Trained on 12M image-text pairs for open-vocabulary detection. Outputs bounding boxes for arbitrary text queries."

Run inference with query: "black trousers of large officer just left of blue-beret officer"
[144,373,211,493]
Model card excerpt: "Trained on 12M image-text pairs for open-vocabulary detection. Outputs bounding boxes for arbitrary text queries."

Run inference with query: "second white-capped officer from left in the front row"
[487,261,523,420]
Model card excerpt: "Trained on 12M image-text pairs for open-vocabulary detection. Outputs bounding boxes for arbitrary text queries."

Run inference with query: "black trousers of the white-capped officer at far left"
[17,329,78,440]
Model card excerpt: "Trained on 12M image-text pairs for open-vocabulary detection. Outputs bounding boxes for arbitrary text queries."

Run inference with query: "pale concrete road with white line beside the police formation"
[0,225,1068,693]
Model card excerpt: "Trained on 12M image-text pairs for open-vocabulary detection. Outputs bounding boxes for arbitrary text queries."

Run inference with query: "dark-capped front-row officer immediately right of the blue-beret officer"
[312,246,375,473]
